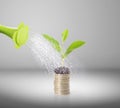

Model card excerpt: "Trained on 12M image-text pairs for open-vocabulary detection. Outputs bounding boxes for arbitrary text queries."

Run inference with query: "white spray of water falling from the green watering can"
[27,33,68,72]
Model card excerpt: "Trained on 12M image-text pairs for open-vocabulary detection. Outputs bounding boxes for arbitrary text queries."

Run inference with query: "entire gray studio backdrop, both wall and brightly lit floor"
[0,0,120,108]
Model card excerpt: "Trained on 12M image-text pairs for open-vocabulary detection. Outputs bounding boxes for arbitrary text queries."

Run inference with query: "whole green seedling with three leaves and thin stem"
[42,29,85,66]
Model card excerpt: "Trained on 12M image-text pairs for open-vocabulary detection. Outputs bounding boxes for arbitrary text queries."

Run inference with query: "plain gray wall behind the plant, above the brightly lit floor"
[0,0,120,69]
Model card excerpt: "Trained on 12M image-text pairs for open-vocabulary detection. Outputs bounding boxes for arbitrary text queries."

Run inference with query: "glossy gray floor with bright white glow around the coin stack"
[0,71,120,107]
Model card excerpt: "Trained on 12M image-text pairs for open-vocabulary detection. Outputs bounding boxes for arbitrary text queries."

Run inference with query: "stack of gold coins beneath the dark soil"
[54,73,70,95]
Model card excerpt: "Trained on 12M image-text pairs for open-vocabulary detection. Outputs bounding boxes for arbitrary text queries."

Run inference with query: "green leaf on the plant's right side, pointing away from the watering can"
[64,40,85,58]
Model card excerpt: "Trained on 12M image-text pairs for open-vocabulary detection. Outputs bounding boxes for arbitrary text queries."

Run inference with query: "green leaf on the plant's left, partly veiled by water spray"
[42,34,61,52]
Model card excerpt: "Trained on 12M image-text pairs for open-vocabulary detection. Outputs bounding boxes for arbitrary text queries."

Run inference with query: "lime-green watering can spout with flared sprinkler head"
[0,23,29,48]
